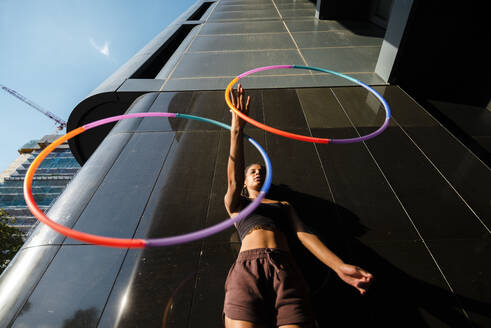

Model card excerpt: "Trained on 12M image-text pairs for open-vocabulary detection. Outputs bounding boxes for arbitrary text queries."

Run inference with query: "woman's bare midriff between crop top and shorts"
[240,228,289,252]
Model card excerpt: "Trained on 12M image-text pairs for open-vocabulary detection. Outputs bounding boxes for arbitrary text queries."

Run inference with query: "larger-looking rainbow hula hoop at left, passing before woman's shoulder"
[24,112,273,248]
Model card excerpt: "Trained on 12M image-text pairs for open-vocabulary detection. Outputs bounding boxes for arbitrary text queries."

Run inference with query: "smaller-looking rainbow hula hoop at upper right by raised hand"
[225,65,390,144]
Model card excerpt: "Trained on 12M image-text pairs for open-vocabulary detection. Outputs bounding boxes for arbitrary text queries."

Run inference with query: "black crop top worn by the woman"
[236,203,288,240]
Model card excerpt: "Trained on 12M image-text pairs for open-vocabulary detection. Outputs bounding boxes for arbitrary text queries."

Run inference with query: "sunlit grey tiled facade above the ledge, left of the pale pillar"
[158,0,386,91]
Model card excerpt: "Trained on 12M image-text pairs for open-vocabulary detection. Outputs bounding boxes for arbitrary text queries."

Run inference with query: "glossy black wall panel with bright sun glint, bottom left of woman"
[99,243,200,327]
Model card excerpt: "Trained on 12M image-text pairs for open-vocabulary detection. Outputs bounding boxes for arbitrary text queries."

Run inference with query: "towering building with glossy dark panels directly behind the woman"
[0,0,491,327]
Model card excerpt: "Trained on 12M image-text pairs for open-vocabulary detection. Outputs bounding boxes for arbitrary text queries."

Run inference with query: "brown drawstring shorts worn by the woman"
[223,248,313,326]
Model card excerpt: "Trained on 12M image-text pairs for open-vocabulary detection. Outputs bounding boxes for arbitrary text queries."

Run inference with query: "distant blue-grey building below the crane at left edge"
[0,135,80,235]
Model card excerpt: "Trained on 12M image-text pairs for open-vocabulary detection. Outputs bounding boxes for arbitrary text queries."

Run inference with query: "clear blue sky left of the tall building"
[0,0,196,172]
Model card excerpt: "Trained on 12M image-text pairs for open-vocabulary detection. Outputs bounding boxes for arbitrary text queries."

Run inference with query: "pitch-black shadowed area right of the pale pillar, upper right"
[389,1,491,166]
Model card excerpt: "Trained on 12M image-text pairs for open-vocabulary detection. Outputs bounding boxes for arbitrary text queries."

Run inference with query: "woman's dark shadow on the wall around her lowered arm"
[268,185,491,327]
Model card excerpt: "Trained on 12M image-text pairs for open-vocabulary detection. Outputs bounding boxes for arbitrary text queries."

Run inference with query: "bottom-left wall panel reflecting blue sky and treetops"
[12,246,126,327]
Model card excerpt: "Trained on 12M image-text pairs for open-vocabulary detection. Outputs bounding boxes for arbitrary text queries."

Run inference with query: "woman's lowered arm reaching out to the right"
[288,204,373,295]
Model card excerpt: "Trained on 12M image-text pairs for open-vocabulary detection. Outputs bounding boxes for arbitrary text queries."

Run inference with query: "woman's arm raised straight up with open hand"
[224,84,251,215]
